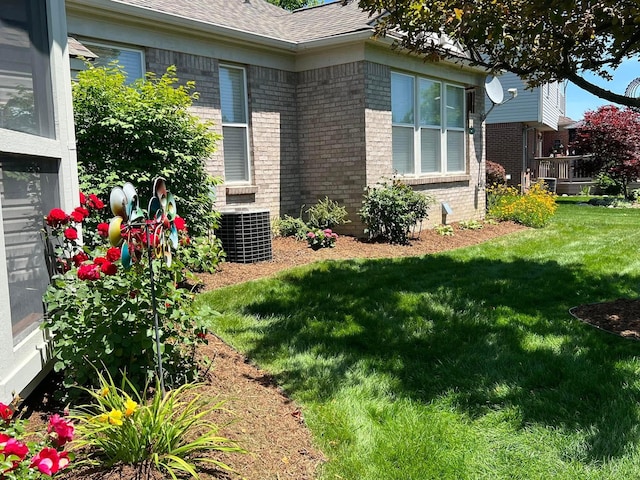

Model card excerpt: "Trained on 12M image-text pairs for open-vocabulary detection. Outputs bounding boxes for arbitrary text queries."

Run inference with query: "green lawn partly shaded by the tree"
[198,201,640,480]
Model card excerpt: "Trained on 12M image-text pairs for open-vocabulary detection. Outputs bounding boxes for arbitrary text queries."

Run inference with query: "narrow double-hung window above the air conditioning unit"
[220,66,250,183]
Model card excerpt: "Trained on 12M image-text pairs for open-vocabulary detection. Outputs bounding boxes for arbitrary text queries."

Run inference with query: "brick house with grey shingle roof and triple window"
[66,0,485,235]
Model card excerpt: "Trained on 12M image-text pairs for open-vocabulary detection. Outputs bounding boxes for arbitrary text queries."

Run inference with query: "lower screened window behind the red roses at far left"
[0,154,60,345]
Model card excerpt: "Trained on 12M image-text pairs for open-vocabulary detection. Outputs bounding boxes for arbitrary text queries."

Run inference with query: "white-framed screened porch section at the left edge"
[0,0,78,403]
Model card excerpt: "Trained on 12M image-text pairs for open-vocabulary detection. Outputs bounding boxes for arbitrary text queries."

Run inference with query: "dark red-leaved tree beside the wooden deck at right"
[575,105,640,198]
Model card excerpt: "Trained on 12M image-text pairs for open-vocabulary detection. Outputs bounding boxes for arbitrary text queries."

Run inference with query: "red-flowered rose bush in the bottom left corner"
[0,403,74,480]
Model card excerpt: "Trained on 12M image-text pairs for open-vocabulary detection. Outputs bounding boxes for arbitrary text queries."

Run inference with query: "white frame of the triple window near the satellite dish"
[391,71,467,177]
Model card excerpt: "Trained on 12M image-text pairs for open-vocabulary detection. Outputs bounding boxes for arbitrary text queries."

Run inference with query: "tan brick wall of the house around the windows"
[147,49,490,235]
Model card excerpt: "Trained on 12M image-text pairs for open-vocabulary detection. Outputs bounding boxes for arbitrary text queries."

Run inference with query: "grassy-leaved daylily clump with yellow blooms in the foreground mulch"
[70,374,244,479]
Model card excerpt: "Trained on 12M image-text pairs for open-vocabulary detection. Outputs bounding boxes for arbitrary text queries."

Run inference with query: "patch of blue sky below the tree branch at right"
[566,58,640,120]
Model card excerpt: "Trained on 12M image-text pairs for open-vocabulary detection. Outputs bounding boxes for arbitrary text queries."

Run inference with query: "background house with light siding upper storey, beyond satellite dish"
[485,73,574,185]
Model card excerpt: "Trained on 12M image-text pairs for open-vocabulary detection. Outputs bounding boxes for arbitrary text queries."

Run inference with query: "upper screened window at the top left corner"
[0,0,54,138]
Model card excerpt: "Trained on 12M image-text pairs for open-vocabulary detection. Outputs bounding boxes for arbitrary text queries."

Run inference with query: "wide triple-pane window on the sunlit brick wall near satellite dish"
[391,73,465,175]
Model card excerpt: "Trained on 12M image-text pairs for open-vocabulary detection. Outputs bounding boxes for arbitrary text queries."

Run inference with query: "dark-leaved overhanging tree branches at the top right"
[352,0,640,107]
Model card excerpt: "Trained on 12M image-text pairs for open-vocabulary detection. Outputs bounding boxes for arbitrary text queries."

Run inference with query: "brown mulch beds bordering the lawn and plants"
[28,222,640,480]
